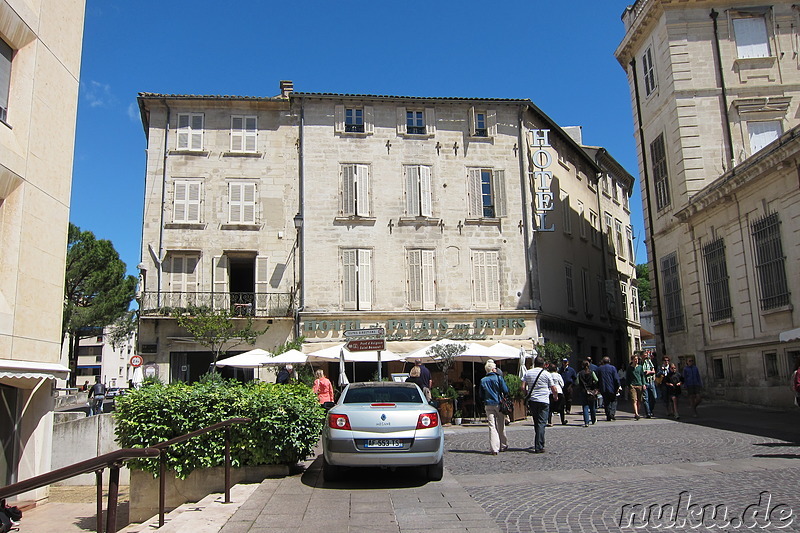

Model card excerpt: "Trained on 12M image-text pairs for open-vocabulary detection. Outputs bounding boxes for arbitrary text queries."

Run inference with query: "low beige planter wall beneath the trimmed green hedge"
[130,465,289,523]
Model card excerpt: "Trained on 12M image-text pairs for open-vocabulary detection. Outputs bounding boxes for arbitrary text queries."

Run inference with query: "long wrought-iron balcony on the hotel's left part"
[139,291,295,318]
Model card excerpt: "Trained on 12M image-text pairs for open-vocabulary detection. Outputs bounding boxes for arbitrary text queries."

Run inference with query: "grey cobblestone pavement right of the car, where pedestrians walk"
[445,413,800,533]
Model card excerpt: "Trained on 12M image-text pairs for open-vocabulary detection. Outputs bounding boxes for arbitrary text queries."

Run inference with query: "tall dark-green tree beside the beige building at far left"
[62,223,136,386]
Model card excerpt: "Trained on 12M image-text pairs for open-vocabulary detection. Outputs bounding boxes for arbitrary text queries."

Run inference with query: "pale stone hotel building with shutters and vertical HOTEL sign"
[140,82,639,379]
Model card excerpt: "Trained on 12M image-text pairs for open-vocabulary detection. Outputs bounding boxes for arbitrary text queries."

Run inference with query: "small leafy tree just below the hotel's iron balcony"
[175,307,269,373]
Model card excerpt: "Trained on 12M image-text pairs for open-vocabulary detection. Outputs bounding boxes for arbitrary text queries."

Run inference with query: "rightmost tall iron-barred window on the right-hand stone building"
[750,213,789,311]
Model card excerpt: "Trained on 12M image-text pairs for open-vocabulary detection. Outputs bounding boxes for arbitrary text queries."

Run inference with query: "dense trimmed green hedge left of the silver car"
[114,374,325,478]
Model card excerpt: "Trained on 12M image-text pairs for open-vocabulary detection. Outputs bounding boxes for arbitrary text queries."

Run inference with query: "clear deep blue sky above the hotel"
[70,0,645,274]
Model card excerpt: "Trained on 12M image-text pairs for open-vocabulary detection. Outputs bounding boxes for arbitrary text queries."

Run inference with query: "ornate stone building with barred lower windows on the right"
[616,0,800,405]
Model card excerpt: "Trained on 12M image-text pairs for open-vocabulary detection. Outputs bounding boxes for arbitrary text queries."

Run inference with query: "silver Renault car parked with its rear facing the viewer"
[322,382,444,481]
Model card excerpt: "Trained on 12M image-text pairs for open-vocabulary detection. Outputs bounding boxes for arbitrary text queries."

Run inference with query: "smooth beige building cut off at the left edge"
[0,0,84,499]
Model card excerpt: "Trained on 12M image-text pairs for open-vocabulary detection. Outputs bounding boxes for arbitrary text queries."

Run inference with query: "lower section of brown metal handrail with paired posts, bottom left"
[0,448,161,533]
